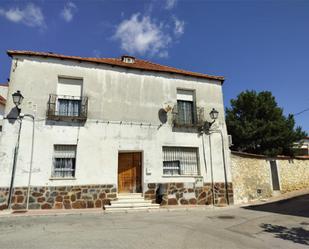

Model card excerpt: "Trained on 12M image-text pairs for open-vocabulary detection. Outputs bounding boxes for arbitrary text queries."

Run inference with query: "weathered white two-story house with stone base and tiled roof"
[0,50,233,209]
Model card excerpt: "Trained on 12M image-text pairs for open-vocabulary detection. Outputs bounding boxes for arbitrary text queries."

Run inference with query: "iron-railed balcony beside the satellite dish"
[172,105,205,128]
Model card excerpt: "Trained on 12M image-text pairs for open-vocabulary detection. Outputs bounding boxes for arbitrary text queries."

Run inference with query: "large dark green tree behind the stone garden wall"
[226,91,307,156]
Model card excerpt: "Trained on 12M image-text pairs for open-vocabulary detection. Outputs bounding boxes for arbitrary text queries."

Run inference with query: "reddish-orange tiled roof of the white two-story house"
[7,50,224,83]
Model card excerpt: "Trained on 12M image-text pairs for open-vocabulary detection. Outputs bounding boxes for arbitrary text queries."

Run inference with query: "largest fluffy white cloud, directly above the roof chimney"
[114,13,172,57]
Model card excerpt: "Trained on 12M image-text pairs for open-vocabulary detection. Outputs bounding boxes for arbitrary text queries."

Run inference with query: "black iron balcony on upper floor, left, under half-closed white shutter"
[47,94,88,122]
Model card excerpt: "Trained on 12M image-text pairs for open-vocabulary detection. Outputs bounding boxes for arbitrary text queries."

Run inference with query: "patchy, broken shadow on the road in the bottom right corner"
[260,222,309,245]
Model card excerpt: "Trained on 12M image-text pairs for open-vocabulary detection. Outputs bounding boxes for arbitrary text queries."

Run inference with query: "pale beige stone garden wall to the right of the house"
[231,152,309,204]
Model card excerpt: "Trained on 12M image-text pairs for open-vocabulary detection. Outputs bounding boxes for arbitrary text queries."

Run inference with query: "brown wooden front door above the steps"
[118,152,142,193]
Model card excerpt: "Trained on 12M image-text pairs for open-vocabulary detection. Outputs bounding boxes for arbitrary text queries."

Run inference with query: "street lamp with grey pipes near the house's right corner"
[202,108,229,205]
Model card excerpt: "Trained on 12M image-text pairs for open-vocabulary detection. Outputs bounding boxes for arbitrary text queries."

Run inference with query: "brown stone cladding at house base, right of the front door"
[144,182,234,206]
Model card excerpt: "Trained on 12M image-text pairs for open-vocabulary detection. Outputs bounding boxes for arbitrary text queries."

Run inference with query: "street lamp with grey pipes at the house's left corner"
[8,90,34,210]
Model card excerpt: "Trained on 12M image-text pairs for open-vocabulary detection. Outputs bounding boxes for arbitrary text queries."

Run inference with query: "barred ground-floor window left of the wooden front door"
[52,145,76,178]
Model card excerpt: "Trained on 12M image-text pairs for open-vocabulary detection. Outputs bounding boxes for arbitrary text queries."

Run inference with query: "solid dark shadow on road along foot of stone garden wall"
[243,194,309,218]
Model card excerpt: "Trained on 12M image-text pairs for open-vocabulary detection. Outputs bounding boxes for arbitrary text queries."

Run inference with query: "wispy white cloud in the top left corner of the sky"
[0,3,45,27]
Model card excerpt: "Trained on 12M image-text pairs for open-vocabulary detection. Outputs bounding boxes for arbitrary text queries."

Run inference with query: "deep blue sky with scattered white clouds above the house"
[0,0,309,131]
